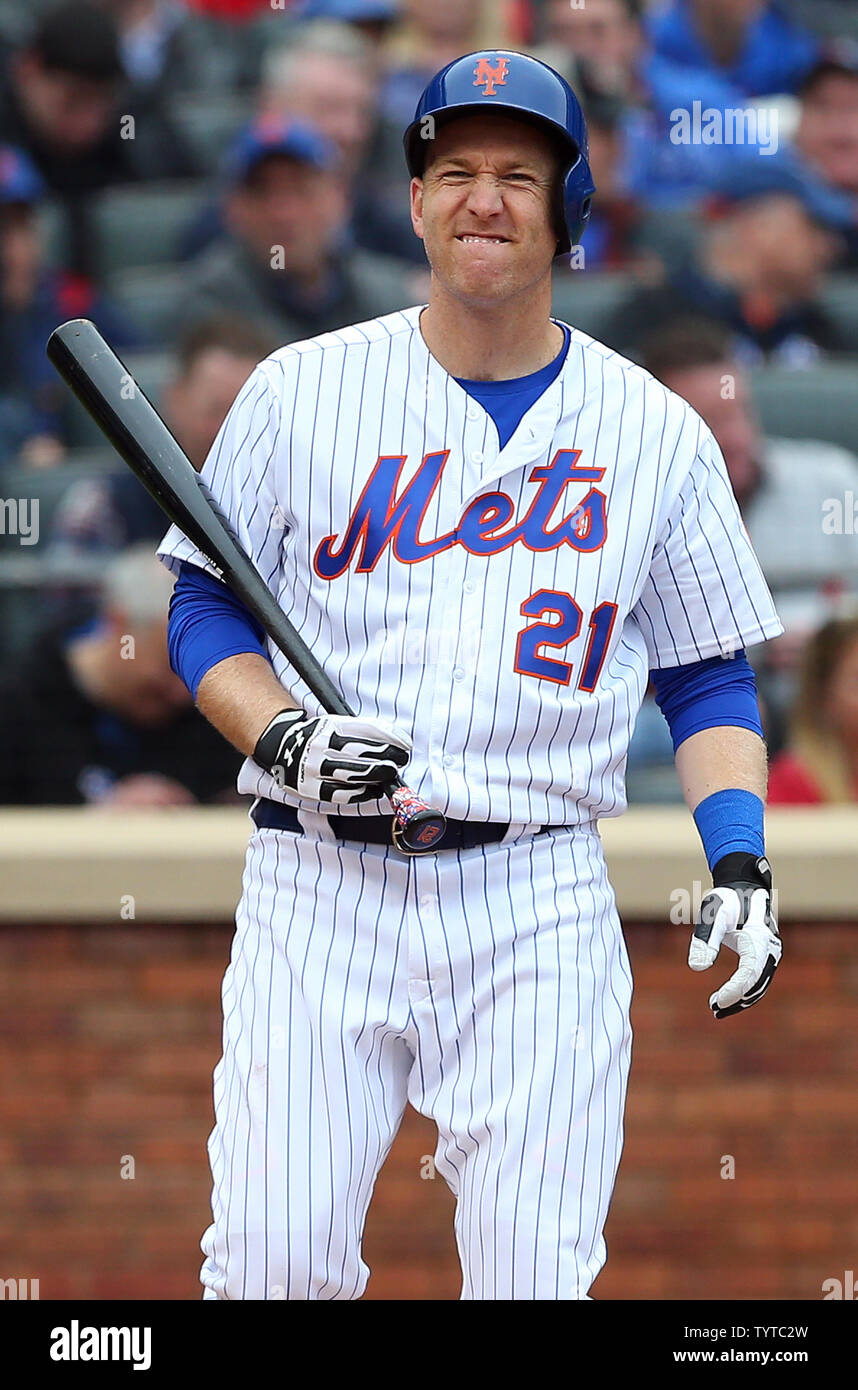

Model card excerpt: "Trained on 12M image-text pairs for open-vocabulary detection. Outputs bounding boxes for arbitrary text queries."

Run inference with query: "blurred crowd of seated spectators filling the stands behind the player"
[0,0,858,805]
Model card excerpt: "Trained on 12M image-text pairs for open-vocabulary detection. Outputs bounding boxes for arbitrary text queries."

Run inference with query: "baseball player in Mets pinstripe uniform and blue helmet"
[160,51,782,1300]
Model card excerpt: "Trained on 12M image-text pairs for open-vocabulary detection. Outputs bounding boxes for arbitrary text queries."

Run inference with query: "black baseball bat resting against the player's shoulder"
[46,318,446,855]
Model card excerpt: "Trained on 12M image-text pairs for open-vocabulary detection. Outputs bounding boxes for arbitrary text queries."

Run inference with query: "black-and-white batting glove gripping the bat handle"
[253,709,412,806]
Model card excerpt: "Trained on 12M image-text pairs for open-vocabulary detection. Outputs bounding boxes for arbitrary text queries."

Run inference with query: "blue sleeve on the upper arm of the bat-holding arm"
[167,562,268,699]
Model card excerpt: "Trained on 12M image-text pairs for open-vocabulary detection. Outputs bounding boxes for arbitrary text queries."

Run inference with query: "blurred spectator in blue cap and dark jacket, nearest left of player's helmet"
[179,120,413,343]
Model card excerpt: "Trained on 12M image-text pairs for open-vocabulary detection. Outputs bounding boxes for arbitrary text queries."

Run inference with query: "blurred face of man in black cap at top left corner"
[17,54,115,154]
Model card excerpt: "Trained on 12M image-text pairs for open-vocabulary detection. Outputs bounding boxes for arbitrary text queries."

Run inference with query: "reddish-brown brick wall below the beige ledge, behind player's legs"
[0,923,858,1300]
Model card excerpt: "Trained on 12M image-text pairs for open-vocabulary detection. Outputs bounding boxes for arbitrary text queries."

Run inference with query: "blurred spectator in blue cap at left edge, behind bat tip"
[0,145,139,466]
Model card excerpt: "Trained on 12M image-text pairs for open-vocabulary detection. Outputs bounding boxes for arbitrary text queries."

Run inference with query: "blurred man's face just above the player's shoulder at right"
[665,361,759,502]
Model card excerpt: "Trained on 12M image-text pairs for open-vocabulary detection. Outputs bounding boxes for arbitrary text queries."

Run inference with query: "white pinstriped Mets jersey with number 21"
[160,306,783,824]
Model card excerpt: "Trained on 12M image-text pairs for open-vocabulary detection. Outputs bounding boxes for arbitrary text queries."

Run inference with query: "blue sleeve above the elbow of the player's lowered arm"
[649,652,762,752]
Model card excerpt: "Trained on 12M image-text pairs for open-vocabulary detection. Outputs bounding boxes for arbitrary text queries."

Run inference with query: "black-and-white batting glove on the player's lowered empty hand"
[688,853,783,1019]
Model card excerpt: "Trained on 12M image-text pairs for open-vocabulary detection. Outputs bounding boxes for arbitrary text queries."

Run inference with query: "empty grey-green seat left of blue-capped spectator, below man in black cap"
[92,182,207,277]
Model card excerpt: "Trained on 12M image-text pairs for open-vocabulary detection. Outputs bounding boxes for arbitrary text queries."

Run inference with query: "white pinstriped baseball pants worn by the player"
[202,816,631,1300]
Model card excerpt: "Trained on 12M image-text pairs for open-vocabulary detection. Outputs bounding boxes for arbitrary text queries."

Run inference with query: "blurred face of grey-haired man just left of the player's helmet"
[266,53,375,168]
